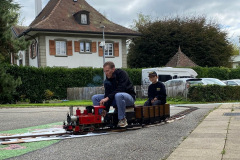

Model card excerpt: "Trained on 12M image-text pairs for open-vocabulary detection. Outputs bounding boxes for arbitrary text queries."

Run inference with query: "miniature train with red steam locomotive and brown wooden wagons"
[63,104,170,133]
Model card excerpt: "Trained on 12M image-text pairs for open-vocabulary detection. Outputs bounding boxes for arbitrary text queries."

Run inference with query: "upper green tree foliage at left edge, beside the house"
[0,0,28,63]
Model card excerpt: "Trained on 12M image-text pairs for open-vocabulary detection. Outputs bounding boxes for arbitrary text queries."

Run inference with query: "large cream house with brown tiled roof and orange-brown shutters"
[12,0,140,68]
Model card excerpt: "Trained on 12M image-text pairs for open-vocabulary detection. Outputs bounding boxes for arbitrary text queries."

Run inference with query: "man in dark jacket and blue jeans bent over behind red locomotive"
[92,61,136,127]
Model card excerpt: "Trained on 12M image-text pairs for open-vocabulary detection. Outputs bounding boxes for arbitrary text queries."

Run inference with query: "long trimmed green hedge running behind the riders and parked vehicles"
[4,65,240,103]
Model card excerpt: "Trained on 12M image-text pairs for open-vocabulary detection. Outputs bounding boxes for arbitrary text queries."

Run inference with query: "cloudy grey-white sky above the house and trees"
[15,0,240,45]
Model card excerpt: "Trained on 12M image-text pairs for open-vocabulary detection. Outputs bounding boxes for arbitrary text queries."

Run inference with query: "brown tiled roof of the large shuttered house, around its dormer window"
[15,0,140,36]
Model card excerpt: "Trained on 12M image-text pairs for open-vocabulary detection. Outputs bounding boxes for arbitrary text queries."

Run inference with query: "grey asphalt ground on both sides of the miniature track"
[0,104,219,160]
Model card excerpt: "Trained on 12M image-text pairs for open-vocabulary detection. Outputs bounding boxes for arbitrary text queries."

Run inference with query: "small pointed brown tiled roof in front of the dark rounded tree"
[166,46,198,67]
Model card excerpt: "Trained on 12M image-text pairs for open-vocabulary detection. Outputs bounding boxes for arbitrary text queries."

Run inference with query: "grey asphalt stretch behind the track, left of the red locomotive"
[0,107,69,131]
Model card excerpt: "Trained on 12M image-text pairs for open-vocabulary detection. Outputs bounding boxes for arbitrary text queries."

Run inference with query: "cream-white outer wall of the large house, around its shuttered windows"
[21,33,131,68]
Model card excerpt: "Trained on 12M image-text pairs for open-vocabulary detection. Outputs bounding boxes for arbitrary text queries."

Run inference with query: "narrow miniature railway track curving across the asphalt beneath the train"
[0,106,198,144]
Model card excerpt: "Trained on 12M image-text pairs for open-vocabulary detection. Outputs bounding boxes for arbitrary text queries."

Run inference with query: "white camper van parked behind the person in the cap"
[142,67,198,85]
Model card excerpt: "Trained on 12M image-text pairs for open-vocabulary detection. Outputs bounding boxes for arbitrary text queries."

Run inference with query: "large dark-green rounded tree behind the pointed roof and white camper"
[128,16,233,68]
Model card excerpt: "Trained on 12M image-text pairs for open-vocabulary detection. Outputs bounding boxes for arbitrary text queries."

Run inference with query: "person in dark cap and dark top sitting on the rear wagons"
[144,71,167,106]
